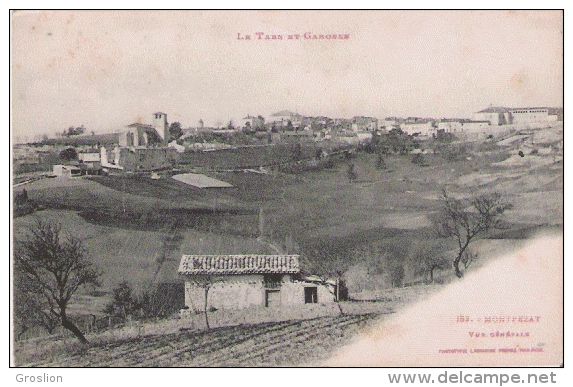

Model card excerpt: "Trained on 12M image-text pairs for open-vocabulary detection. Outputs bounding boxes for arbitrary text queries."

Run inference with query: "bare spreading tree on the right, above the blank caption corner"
[436,189,511,278]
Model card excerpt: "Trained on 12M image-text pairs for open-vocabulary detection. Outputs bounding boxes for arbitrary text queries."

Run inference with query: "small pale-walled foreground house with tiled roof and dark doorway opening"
[179,255,336,311]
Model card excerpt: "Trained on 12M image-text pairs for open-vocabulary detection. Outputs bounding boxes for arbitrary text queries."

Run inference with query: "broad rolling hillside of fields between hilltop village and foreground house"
[14,127,563,352]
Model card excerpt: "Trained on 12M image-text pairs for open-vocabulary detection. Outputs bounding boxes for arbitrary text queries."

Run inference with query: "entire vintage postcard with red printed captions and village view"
[10,10,564,370]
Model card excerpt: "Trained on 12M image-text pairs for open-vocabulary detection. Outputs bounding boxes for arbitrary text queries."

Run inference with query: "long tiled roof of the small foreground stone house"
[179,255,300,275]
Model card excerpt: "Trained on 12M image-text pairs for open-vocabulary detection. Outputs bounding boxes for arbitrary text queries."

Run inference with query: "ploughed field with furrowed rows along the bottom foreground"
[20,313,380,367]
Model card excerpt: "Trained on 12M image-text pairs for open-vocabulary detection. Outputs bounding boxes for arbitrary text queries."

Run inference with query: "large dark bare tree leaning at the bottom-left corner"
[14,220,101,343]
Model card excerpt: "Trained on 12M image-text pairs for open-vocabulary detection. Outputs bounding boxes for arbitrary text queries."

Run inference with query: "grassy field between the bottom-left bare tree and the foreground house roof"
[14,210,269,290]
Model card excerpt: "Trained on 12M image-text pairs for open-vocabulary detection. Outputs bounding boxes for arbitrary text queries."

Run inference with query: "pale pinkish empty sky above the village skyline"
[11,11,563,140]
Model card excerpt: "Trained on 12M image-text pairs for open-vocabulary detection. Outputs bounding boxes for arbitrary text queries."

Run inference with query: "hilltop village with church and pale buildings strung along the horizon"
[13,107,563,175]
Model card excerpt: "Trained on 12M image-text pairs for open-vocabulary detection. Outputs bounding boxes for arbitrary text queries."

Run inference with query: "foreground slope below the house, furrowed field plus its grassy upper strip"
[15,285,442,367]
